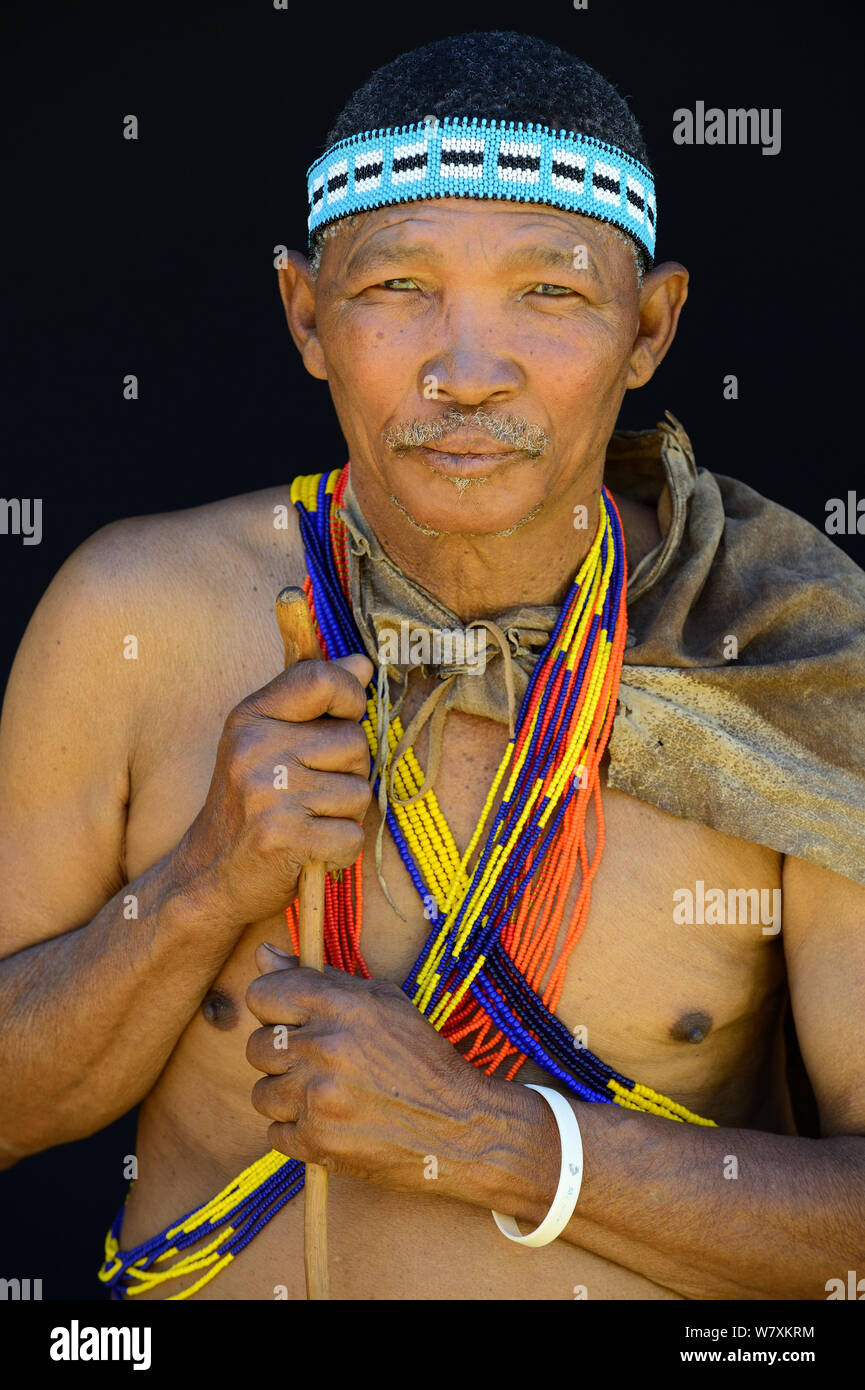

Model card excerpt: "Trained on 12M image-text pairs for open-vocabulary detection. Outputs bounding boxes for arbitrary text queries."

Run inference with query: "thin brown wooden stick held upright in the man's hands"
[277,587,331,1301]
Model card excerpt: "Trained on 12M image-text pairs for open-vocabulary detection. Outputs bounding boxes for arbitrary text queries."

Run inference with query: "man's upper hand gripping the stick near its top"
[172,655,373,924]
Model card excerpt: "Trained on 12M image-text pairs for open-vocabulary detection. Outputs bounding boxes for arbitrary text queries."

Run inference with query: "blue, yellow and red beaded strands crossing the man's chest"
[99,466,713,1300]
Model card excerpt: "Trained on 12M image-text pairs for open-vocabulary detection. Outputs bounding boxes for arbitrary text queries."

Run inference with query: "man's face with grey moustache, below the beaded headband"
[316,199,650,535]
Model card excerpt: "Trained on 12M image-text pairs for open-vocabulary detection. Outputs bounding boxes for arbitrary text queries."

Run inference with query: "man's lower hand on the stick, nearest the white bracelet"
[246,945,505,1191]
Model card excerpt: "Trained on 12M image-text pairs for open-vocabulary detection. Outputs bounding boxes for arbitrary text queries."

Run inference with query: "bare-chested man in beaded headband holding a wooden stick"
[0,35,865,1300]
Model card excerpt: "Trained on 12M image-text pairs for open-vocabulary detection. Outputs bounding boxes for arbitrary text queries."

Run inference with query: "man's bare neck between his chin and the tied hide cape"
[352,478,661,623]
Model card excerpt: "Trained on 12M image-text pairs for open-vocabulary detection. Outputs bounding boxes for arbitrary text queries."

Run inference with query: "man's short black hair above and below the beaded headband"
[310,31,651,272]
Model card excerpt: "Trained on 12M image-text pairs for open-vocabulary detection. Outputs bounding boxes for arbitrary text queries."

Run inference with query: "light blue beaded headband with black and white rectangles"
[306,115,656,264]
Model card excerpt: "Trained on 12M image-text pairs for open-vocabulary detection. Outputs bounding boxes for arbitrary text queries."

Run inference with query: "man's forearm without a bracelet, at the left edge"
[0,855,242,1166]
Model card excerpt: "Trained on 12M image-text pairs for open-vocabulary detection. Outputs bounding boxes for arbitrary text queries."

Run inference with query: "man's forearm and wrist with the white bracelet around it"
[446,1083,865,1298]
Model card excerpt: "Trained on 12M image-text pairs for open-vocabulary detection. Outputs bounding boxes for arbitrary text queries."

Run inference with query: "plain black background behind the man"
[0,0,865,1298]
